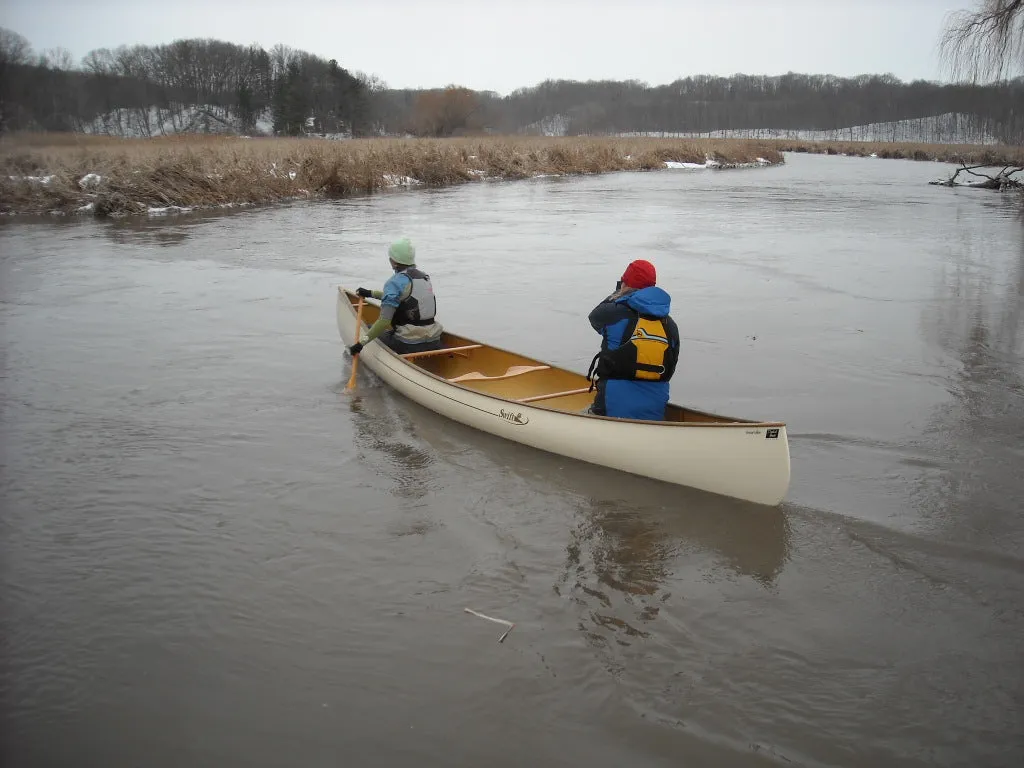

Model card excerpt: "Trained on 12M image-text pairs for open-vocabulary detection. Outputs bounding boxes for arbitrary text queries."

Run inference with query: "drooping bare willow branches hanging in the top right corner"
[940,0,1024,83]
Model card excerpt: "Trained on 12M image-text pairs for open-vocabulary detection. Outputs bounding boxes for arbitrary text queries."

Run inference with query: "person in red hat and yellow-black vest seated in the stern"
[589,261,679,421]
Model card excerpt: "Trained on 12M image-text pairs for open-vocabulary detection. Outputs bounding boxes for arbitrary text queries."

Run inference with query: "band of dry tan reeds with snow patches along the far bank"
[0,133,1024,216]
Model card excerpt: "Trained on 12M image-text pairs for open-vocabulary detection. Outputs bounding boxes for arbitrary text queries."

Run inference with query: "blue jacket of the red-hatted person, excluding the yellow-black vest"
[588,286,679,421]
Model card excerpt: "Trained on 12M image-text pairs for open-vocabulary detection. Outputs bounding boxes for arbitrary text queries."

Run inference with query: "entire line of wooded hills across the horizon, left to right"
[0,30,1024,143]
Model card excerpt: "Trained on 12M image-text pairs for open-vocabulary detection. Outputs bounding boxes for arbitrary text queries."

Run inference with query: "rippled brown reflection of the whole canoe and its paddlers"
[351,382,791,645]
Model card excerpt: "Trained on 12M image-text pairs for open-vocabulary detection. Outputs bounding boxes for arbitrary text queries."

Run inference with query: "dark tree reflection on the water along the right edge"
[915,225,1024,551]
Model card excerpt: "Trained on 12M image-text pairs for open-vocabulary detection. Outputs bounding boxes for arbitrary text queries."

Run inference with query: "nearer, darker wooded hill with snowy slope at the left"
[0,30,372,135]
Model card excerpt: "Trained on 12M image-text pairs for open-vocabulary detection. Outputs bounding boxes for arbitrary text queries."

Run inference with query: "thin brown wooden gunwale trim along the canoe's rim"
[338,286,785,429]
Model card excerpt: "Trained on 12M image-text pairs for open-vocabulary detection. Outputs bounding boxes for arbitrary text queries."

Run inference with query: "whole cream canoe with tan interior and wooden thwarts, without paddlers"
[338,288,790,506]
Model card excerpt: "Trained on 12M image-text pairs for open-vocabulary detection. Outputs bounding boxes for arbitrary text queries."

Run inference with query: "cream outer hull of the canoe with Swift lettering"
[337,290,790,506]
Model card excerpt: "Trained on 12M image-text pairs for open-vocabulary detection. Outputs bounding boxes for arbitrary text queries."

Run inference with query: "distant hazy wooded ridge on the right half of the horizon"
[485,74,1024,143]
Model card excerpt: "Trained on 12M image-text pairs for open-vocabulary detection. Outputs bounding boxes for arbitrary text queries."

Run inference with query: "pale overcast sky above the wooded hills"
[0,0,977,94]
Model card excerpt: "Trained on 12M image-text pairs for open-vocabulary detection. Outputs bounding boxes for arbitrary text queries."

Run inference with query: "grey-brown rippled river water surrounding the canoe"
[0,155,1024,768]
